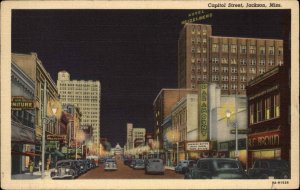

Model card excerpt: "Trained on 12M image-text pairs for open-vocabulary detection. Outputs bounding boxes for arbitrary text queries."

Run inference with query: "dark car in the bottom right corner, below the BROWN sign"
[248,159,291,179]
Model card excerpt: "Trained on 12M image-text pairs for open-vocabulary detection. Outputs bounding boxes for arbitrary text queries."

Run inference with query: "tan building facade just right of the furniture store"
[12,53,61,166]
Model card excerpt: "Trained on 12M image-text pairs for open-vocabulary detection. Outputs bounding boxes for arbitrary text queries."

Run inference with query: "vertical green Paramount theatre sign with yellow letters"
[198,84,208,141]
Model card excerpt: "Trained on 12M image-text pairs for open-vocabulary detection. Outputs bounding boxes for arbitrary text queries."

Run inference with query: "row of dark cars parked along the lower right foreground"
[182,158,290,179]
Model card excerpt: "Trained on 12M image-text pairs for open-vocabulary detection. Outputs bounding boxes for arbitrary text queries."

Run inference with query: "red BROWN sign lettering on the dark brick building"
[248,131,280,149]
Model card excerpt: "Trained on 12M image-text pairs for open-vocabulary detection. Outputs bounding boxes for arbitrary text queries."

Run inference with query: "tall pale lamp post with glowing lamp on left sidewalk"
[42,81,57,179]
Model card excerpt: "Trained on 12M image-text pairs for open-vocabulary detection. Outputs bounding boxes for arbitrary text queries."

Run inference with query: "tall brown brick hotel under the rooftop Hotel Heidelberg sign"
[178,23,284,94]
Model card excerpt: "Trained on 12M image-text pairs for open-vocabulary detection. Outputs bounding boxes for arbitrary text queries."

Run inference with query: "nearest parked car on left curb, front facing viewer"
[50,160,80,179]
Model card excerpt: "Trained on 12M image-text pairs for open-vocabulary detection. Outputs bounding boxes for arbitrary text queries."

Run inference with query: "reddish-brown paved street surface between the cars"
[78,160,184,180]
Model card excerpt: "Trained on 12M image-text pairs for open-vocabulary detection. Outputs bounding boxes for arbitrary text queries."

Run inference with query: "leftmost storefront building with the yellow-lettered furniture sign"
[11,63,35,174]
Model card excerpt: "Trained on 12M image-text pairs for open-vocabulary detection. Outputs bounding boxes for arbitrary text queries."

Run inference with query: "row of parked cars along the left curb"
[50,159,96,179]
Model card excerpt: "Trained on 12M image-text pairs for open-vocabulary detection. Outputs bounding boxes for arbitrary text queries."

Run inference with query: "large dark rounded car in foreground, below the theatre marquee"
[184,158,248,179]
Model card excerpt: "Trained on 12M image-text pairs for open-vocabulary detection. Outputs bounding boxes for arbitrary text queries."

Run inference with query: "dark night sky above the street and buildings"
[12,10,290,145]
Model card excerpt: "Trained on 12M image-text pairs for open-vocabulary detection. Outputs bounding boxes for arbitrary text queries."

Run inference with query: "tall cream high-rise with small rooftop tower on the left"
[57,71,101,147]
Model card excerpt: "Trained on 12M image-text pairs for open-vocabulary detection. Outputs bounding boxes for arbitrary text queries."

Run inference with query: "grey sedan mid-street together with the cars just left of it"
[124,158,165,174]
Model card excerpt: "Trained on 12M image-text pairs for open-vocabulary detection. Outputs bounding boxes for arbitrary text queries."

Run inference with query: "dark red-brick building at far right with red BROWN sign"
[247,66,291,167]
